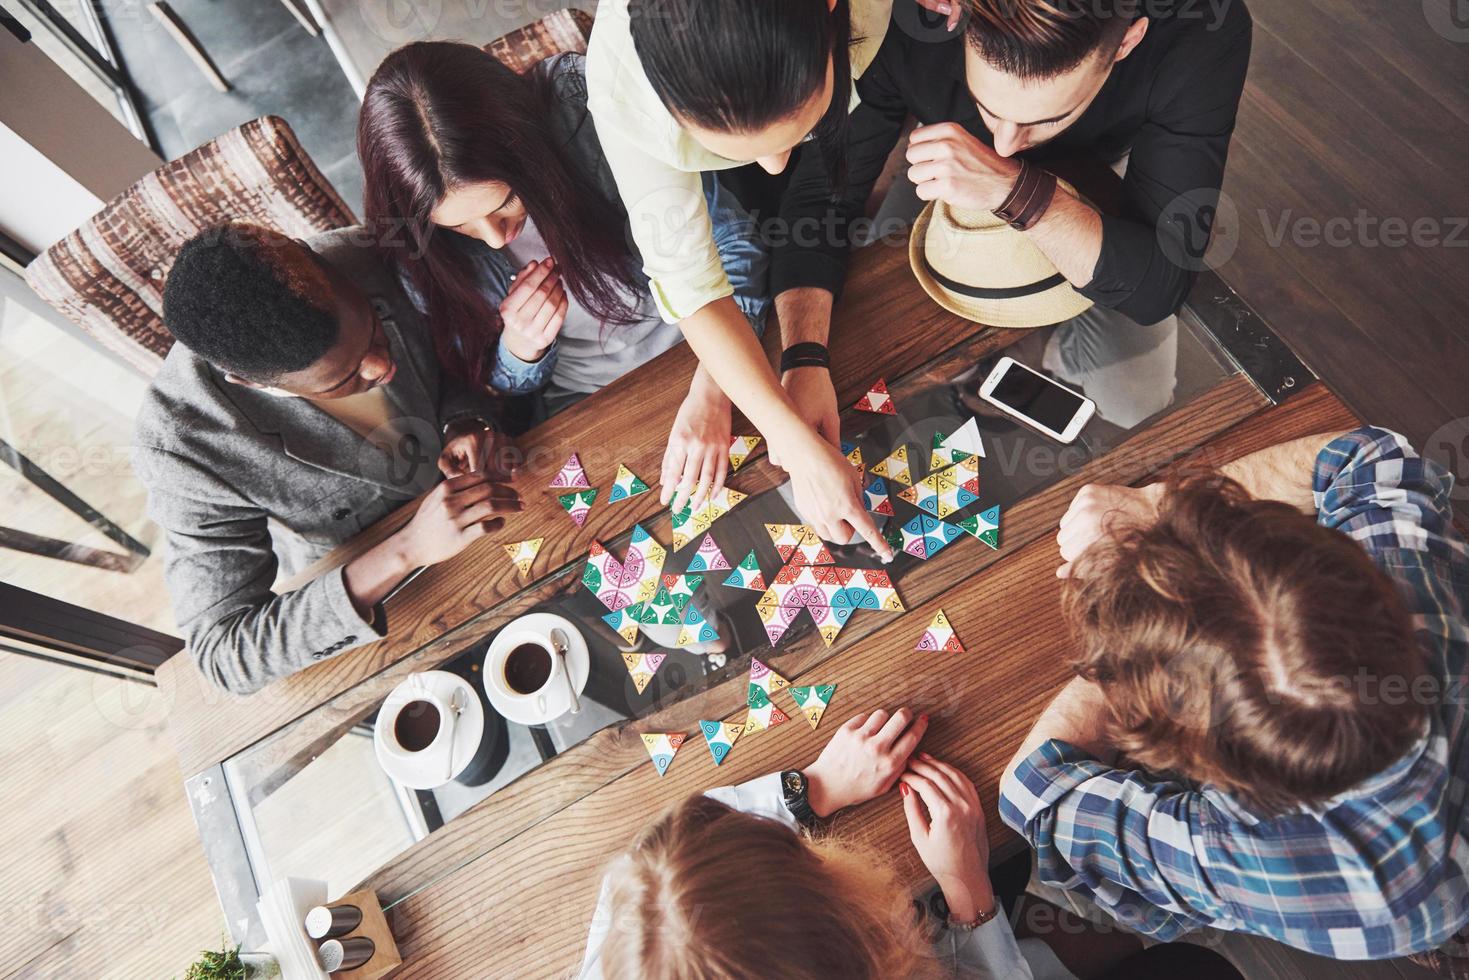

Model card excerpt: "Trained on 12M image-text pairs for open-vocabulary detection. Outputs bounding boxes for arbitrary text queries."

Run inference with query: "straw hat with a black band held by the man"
[908,181,1091,328]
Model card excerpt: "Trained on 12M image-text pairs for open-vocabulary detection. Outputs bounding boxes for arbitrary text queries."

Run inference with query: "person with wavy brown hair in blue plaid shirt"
[1000,428,1469,959]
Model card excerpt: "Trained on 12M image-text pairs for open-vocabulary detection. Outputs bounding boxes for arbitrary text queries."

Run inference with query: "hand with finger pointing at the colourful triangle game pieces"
[771,426,893,563]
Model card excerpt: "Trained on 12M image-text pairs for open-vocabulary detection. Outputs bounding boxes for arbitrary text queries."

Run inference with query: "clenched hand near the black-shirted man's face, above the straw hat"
[906,122,1019,212]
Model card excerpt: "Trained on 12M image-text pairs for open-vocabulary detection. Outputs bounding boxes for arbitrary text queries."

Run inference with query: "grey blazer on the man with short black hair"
[132,228,494,693]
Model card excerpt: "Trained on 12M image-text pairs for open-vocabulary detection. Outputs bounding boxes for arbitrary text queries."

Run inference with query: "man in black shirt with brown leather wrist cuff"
[771,0,1250,432]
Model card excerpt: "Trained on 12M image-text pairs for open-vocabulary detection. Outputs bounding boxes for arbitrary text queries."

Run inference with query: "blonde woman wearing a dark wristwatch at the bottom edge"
[582,708,1071,980]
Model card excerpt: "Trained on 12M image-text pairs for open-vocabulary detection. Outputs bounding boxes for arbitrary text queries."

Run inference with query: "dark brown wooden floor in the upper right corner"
[1219,0,1469,514]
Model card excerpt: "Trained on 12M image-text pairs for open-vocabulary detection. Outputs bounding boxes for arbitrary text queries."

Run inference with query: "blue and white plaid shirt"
[1000,428,1469,959]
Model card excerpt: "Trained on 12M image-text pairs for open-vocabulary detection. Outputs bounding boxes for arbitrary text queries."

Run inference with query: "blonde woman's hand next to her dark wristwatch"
[805,708,928,817]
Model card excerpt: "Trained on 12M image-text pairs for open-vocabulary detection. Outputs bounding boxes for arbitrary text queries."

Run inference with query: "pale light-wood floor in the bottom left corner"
[0,652,225,980]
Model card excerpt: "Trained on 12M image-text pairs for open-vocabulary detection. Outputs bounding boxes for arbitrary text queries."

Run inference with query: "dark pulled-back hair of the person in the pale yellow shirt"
[629,0,853,184]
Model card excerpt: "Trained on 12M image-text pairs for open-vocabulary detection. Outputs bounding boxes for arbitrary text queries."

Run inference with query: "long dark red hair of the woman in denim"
[357,41,642,382]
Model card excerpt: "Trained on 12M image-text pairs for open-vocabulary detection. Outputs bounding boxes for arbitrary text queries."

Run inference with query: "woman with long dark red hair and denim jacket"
[357,41,770,505]
